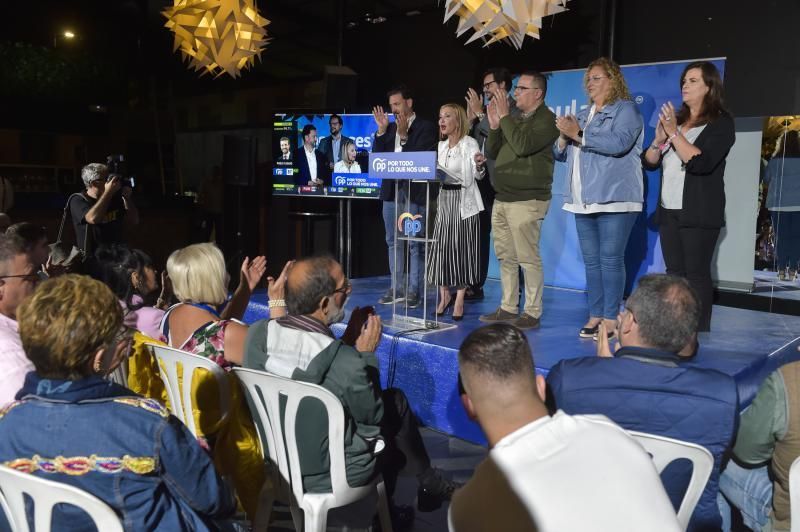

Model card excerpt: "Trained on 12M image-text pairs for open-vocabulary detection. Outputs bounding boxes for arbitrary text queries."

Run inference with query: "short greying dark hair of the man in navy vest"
[625,273,700,353]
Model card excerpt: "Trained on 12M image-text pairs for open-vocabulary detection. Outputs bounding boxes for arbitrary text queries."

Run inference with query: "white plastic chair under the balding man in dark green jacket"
[233,368,392,532]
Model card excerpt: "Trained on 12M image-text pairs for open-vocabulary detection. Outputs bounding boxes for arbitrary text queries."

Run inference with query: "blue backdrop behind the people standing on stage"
[489,59,725,291]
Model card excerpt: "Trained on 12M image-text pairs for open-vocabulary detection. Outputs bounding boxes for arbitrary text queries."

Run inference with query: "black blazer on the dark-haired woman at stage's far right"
[642,113,736,229]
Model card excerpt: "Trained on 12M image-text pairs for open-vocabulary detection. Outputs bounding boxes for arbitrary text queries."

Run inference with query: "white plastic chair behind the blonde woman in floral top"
[147,344,231,437]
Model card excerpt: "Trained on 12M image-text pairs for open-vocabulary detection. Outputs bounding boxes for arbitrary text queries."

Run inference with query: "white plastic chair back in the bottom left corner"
[0,466,123,532]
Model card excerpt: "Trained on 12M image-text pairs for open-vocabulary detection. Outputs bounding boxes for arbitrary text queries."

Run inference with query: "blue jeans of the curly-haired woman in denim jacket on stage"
[575,212,640,320]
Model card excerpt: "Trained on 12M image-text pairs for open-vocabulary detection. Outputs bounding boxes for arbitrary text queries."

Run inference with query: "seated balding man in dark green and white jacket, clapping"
[244,257,455,521]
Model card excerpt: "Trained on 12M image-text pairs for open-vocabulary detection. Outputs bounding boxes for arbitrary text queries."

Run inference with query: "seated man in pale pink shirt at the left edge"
[0,235,39,407]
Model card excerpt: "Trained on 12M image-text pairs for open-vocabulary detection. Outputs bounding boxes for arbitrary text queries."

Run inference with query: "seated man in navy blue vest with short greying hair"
[547,274,738,531]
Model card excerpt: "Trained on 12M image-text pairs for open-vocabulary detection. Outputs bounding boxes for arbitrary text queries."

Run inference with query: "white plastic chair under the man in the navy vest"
[628,430,714,530]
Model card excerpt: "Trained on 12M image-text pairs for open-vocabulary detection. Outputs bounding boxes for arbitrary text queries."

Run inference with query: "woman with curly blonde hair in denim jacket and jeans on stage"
[554,57,644,338]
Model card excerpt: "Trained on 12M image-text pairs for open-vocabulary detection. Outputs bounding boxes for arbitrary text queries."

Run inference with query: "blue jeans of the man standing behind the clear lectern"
[383,187,427,295]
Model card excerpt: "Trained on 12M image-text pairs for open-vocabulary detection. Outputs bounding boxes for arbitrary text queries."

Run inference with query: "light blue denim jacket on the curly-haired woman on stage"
[553,100,644,204]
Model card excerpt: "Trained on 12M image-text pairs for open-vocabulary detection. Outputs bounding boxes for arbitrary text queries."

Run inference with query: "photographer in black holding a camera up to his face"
[68,163,139,254]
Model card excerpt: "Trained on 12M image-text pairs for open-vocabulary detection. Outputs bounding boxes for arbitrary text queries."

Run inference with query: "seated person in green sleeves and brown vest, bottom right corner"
[719,362,800,532]
